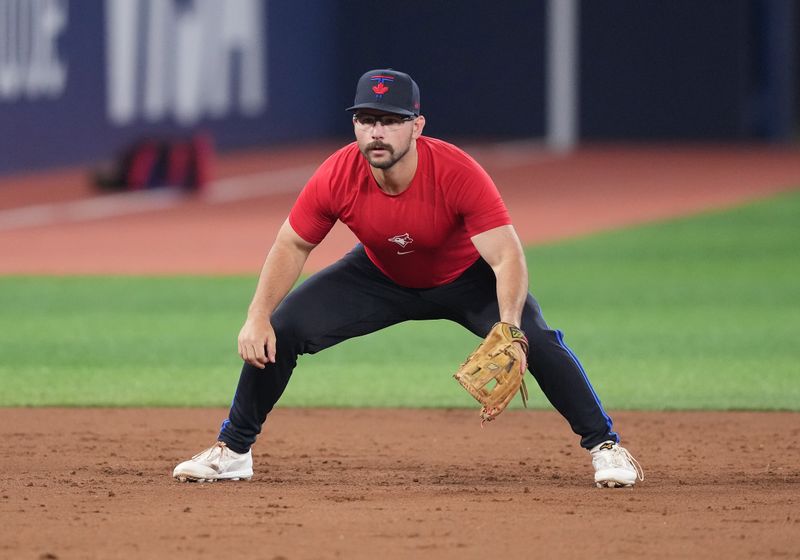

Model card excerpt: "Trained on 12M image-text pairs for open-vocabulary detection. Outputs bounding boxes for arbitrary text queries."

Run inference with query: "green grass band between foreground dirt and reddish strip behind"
[0,193,800,410]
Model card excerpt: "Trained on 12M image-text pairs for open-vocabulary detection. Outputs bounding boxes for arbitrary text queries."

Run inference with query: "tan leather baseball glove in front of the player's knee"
[453,322,528,424]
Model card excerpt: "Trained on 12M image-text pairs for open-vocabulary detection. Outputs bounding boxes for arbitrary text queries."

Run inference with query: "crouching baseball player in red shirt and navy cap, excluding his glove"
[173,69,643,487]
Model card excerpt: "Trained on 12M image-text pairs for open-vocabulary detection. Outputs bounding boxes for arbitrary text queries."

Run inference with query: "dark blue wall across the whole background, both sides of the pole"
[0,0,798,173]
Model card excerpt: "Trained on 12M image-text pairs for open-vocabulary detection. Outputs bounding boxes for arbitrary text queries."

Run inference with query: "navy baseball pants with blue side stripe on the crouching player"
[219,245,619,453]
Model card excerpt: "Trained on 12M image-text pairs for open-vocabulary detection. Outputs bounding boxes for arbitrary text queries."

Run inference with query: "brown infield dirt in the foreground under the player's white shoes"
[0,409,800,560]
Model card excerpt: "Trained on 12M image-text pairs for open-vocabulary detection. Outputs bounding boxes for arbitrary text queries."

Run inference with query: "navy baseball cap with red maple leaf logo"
[347,68,419,117]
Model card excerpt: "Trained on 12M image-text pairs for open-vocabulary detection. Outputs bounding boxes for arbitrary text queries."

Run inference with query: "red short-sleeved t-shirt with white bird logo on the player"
[289,136,511,288]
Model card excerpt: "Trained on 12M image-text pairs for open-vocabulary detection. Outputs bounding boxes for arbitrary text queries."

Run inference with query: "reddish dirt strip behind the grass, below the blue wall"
[0,143,800,275]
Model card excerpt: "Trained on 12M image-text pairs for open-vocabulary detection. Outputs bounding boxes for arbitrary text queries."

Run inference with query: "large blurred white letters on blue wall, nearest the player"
[105,0,267,125]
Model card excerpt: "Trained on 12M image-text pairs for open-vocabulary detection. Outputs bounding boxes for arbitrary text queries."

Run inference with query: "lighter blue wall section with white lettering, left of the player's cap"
[0,0,341,171]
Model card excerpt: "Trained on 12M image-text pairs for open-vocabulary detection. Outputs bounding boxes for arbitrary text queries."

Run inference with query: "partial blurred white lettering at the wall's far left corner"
[0,0,67,103]
